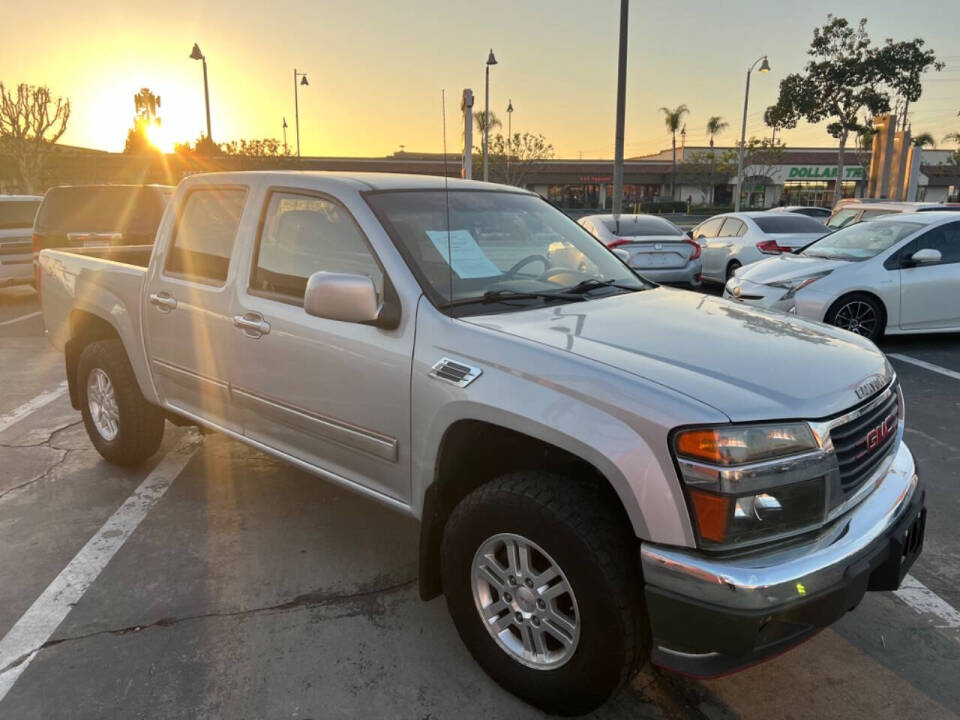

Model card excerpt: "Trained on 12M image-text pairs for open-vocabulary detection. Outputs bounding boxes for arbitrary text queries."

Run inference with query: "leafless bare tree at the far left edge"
[0,82,70,192]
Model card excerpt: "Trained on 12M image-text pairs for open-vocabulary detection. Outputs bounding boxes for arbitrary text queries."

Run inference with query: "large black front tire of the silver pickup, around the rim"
[441,472,651,715]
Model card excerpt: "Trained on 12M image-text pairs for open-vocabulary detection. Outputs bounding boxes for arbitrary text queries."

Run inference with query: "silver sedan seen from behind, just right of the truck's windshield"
[577,215,700,287]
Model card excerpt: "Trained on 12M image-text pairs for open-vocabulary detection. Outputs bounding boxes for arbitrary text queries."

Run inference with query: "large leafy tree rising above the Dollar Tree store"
[764,15,943,202]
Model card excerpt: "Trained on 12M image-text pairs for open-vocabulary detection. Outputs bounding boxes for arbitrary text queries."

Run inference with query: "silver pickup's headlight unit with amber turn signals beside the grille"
[673,423,829,550]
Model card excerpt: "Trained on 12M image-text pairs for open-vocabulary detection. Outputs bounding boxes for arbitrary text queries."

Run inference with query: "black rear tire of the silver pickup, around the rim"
[77,340,164,465]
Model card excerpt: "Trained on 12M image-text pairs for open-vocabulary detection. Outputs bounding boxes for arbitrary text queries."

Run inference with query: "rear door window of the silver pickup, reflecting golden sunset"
[165,188,247,285]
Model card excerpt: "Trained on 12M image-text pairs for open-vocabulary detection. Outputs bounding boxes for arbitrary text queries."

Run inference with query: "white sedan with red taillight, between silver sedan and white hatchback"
[691,211,827,284]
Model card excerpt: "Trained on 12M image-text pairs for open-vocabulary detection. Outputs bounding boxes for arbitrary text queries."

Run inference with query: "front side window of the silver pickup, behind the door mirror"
[250,192,383,303]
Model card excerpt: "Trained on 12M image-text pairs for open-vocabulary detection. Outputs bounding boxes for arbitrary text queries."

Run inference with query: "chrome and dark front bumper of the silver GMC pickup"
[640,443,926,677]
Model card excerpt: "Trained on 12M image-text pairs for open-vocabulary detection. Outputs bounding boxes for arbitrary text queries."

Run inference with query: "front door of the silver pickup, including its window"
[229,189,414,502]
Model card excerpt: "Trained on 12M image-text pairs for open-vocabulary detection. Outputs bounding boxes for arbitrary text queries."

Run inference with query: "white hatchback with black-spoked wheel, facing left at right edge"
[723,212,960,340]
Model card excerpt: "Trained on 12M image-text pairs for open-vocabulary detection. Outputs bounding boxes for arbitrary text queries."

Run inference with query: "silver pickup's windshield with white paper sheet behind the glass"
[365,190,648,314]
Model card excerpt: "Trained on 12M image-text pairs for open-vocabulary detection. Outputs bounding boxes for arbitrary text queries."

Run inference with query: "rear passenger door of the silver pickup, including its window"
[142,185,247,432]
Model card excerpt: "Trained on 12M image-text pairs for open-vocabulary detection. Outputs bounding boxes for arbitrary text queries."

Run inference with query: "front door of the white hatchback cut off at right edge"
[900,222,960,330]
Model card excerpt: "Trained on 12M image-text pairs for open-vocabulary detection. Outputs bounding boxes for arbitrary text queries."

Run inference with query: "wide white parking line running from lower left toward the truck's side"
[0,432,199,702]
